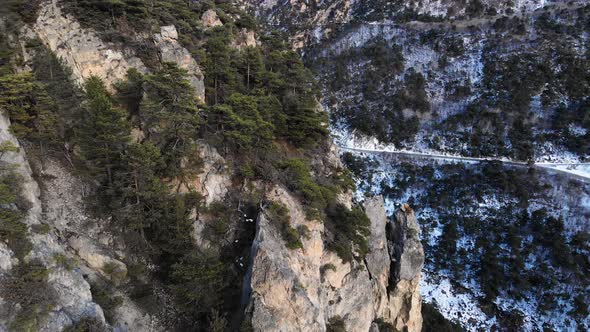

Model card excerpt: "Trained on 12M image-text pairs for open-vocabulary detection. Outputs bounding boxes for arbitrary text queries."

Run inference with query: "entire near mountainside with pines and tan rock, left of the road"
[0,0,424,331]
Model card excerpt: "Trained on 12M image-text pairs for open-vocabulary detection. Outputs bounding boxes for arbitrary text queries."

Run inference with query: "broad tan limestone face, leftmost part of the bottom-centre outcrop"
[250,187,326,331]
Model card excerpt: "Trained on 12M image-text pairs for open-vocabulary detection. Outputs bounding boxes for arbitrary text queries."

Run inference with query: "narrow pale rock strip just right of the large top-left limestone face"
[154,25,205,102]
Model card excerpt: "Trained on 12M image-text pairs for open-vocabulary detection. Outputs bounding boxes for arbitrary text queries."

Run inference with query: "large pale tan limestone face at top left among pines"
[33,0,147,86]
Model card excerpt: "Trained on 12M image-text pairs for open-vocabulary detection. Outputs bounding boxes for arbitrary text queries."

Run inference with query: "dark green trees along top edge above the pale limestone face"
[62,0,255,68]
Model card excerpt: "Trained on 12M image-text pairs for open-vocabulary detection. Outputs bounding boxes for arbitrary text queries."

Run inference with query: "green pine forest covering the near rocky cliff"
[0,0,366,330]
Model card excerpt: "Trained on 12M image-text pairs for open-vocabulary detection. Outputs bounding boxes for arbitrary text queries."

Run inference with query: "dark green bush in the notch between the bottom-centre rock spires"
[326,204,371,262]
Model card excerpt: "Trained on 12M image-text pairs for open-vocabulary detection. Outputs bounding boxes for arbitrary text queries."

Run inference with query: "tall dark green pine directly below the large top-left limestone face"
[78,76,130,187]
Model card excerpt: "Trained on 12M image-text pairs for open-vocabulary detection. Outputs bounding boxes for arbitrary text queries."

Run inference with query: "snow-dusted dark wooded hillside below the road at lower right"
[343,152,590,331]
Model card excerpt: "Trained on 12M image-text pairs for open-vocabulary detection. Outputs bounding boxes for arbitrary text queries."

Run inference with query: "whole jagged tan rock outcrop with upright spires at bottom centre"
[248,192,424,331]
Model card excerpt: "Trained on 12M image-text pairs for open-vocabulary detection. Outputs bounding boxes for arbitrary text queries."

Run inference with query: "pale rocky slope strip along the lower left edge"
[0,114,104,332]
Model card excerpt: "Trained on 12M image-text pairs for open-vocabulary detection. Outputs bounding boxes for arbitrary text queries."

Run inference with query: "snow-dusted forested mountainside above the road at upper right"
[243,0,590,160]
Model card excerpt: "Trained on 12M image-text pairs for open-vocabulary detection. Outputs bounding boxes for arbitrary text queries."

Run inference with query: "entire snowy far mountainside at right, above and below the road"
[242,0,590,331]
